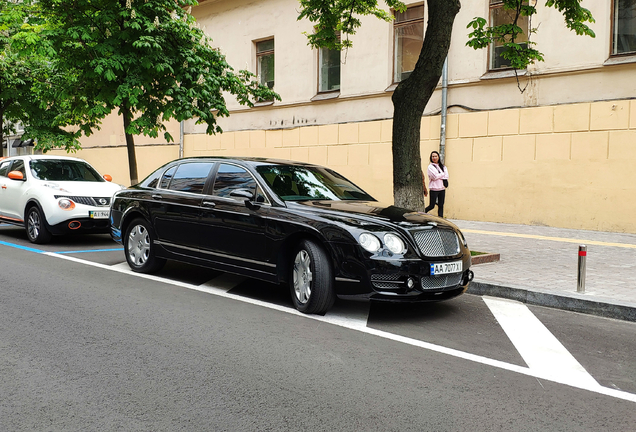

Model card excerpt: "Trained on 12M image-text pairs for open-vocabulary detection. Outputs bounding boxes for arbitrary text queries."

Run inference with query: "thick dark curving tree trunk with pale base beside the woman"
[392,0,460,210]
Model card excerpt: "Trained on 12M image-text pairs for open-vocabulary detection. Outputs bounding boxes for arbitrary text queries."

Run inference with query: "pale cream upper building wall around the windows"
[193,0,636,129]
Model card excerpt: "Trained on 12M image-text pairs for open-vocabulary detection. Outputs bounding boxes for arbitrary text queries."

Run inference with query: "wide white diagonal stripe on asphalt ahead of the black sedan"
[483,296,599,386]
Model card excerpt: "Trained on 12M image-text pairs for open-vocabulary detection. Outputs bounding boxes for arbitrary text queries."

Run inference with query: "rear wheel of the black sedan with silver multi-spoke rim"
[124,218,166,273]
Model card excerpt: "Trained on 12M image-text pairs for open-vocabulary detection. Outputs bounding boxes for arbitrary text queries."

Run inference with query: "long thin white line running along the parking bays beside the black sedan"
[44,252,636,403]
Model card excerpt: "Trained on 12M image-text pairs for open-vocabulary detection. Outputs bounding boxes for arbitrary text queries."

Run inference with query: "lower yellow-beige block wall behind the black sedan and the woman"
[184,100,636,233]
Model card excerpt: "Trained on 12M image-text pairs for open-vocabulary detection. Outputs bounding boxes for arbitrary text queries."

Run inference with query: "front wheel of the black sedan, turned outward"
[289,240,336,315]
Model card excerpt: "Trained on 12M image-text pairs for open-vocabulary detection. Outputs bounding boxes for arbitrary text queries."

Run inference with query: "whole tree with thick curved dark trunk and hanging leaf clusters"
[298,0,594,210]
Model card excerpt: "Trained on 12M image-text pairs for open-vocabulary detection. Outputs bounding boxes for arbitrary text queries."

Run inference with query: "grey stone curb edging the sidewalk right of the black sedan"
[466,281,636,322]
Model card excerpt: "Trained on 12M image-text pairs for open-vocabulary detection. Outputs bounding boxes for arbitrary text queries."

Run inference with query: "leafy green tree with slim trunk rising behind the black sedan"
[38,0,280,184]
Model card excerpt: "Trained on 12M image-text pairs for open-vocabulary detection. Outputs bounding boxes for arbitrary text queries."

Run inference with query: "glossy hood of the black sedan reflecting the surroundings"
[286,200,458,229]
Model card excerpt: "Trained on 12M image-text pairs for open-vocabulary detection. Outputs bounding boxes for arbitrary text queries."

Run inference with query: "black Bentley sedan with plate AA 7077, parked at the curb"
[111,157,473,314]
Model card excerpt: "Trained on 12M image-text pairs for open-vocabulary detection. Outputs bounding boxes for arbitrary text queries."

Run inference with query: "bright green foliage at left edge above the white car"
[0,0,79,155]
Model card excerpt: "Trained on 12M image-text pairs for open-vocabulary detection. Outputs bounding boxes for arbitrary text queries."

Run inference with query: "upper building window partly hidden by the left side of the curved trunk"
[393,5,424,82]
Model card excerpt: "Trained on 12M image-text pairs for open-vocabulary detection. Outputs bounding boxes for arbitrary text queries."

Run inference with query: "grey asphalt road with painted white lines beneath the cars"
[0,226,636,431]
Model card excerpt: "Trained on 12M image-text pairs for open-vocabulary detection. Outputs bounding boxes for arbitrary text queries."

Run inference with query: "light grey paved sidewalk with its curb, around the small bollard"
[451,220,636,321]
